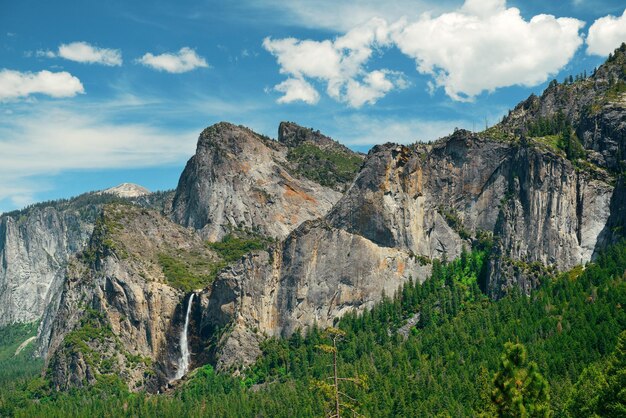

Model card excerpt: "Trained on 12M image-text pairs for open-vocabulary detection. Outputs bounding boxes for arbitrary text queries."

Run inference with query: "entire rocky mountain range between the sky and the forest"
[0,47,626,400]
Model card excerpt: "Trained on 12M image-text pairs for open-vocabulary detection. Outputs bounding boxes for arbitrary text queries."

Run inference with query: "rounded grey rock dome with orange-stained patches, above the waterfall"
[172,123,341,241]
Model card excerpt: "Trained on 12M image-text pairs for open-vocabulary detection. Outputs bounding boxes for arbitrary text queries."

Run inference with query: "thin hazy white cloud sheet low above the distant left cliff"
[0,104,197,206]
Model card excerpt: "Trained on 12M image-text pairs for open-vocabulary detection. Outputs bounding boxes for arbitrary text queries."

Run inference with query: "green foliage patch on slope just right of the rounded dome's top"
[287,143,363,187]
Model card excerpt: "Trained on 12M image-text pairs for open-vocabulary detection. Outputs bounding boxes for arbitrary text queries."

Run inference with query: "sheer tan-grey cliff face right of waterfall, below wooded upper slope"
[203,131,613,369]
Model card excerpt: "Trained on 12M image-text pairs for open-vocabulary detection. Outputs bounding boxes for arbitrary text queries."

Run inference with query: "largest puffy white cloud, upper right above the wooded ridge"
[392,0,583,100]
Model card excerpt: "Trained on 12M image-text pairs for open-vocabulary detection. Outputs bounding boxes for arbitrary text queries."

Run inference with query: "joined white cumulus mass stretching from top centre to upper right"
[263,0,584,103]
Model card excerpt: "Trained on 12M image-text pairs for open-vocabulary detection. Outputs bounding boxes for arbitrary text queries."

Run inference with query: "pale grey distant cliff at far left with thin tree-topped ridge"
[0,192,171,327]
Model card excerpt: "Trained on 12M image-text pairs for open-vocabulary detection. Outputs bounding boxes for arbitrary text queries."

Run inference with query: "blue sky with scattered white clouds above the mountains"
[0,0,626,212]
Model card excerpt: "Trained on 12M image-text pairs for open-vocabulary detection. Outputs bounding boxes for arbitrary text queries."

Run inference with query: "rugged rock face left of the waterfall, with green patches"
[43,205,217,391]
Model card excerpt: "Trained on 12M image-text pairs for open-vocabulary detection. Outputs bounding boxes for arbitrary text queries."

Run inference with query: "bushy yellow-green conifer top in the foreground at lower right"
[491,342,550,417]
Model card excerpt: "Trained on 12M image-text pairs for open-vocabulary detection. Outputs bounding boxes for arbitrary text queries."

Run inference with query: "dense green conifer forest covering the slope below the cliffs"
[0,243,626,417]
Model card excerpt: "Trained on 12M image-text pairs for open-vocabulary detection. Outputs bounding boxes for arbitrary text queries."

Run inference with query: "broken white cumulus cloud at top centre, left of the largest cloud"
[263,19,406,107]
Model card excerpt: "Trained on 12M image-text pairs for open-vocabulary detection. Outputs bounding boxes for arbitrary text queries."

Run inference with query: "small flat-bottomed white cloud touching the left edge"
[0,69,85,101]
